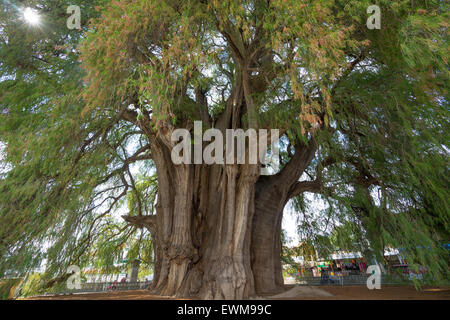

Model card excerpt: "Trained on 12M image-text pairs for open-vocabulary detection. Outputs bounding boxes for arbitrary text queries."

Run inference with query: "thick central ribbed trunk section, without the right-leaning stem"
[148,141,259,299]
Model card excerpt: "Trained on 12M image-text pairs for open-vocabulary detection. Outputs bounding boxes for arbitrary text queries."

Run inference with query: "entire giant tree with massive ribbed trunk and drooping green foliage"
[0,0,448,299]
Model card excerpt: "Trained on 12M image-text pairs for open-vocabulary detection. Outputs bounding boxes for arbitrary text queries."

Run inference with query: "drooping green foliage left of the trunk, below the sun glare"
[0,1,155,288]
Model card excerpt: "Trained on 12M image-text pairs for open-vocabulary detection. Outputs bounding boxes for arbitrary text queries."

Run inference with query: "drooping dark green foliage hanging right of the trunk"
[284,1,450,281]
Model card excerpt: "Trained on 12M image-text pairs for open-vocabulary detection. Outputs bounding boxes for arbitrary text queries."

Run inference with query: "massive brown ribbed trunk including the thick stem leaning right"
[126,131,315,299]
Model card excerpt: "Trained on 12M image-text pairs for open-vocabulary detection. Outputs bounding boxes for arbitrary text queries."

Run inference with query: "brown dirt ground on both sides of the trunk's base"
[28,286,450,300]
